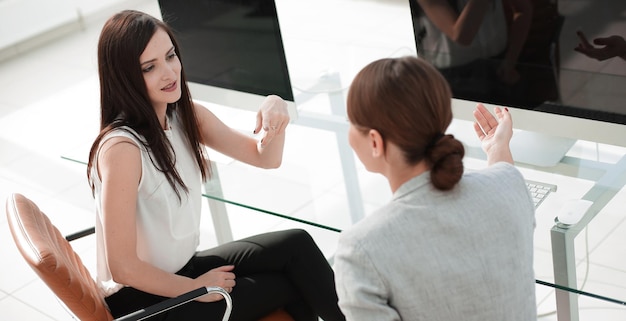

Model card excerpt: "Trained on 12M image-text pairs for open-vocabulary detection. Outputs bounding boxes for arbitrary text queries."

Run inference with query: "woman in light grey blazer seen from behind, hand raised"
[334,57,536,321]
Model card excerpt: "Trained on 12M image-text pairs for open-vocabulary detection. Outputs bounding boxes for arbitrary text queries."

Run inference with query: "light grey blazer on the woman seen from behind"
[334,163,536,321]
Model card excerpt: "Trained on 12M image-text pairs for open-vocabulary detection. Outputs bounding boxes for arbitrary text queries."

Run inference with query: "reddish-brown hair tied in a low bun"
[347,56,465,190]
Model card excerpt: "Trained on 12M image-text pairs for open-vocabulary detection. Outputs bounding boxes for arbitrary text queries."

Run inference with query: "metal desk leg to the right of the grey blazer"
[550,226,578,321]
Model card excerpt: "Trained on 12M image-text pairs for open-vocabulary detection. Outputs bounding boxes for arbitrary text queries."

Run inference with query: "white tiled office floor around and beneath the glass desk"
[0,0,626,321]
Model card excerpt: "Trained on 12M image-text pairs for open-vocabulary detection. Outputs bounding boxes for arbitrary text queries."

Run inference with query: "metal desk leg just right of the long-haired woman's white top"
[204,161,233,244]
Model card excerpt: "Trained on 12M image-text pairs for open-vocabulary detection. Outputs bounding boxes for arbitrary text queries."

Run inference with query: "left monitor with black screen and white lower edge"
[159,0,295,114]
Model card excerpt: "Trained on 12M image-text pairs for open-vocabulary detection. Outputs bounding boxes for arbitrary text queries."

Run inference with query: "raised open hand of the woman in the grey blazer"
[474,104,513,165]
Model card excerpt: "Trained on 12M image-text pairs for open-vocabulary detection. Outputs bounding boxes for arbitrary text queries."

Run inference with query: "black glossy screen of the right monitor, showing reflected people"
[410,0,626,124]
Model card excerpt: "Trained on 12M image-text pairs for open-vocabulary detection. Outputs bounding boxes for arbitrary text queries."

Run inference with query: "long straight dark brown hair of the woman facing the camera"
[87,10,211,198]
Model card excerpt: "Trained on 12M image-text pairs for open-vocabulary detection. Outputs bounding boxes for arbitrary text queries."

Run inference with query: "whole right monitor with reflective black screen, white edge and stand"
[409,0,626,166]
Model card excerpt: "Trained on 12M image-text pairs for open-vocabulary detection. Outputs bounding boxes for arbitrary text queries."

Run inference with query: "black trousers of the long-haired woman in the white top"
[105,229,345,321]
